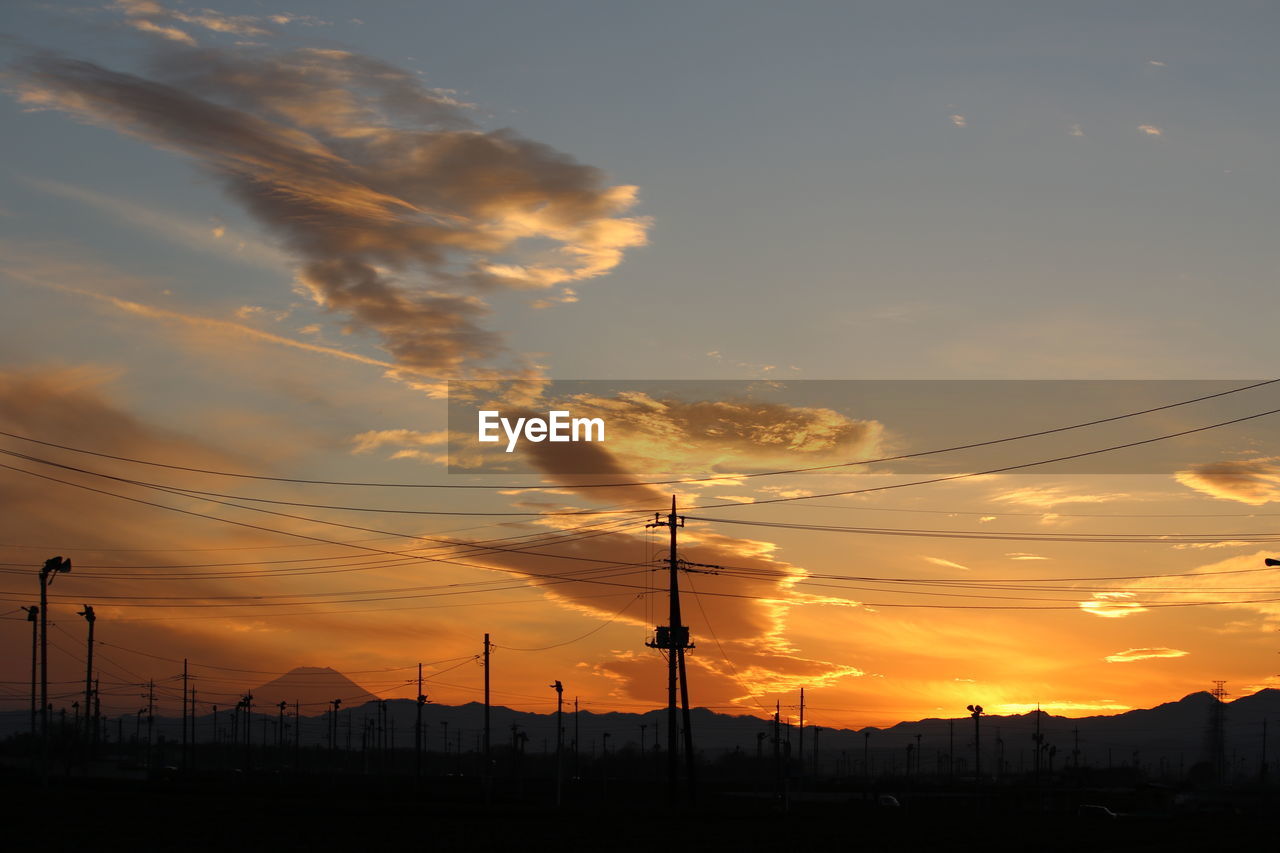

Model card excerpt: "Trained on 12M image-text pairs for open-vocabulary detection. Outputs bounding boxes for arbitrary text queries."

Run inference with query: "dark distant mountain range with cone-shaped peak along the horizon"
[0,667,1280,774]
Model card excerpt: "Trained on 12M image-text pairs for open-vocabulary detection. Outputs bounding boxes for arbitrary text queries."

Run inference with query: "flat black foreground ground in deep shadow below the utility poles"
[3,776,1276,852]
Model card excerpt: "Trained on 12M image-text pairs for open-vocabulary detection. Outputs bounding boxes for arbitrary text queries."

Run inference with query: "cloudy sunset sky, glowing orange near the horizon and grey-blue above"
[0,0,1280,727]
